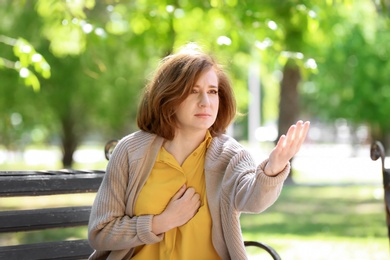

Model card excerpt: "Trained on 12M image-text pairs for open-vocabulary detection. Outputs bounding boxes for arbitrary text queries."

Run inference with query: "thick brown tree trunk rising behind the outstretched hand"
[277,59,301,183]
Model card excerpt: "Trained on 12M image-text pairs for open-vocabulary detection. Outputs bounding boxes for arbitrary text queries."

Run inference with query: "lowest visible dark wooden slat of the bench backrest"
[0,240,93,260]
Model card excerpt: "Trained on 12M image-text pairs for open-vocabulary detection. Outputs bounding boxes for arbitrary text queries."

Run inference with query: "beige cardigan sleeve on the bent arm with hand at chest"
[88,139,163,251]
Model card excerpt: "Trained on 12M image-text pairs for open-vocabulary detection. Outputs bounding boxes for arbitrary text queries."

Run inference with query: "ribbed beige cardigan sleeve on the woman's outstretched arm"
[206,135,290,213]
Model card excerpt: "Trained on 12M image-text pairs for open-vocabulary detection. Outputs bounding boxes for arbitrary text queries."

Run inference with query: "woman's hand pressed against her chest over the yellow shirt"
[152,185,200,235]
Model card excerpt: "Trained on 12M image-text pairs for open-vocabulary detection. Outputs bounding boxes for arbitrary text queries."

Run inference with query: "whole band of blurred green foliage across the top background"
[0,0,390,166]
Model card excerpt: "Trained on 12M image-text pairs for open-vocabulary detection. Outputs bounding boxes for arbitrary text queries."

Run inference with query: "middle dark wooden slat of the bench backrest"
[0,206,91,233]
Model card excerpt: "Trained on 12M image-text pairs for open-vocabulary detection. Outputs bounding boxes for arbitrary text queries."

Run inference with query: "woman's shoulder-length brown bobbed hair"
[137,44,236,140]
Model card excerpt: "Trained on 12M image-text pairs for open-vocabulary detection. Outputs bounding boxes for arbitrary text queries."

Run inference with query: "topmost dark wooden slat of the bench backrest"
[0,172,104,197]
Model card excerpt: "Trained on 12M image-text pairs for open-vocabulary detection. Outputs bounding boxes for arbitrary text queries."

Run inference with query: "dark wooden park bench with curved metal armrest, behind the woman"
[0,142,281,260]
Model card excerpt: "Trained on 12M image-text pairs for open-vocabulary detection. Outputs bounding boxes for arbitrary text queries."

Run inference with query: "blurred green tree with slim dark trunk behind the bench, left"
[1,1,143,167]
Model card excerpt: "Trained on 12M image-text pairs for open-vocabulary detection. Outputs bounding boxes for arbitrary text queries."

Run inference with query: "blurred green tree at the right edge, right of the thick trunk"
[302,1,390,150]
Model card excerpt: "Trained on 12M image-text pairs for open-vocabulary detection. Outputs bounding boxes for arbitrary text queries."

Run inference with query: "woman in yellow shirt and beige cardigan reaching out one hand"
[89,43,309,259]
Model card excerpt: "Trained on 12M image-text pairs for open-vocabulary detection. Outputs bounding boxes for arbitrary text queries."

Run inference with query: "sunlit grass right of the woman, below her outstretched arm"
[241,186,389,259]
